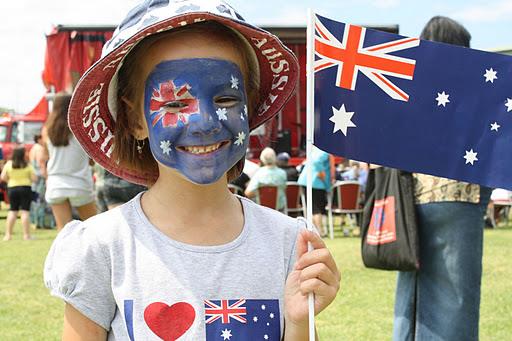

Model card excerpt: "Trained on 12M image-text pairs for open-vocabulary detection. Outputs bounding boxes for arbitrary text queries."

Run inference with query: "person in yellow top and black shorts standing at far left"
[0,147,36,241]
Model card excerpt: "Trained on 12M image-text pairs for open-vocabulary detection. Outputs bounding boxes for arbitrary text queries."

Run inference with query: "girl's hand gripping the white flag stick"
[284,230,341,329]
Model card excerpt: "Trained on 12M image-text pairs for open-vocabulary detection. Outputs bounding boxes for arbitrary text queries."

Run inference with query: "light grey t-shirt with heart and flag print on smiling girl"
[44,195,305,341]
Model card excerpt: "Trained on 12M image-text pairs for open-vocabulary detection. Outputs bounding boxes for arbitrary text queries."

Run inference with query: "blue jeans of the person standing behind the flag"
[393,187,491,341]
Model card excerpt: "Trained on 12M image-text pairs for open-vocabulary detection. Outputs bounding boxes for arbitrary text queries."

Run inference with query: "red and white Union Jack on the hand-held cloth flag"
[314,14,420,101]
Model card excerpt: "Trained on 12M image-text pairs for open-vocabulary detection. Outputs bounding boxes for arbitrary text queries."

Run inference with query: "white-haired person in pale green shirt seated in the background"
[245,147,286,211]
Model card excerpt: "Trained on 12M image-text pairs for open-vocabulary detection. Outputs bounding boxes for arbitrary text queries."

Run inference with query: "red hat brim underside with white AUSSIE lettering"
[68,12,299,184]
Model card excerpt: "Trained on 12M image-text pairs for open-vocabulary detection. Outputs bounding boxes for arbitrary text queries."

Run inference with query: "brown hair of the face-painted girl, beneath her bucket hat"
[113,21,259,181]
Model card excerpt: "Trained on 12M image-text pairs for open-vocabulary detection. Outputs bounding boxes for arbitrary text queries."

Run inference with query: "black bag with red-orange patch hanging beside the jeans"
[361,167,419,271]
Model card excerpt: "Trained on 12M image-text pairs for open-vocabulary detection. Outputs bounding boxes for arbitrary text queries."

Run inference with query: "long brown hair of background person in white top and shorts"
[45,92,71,147]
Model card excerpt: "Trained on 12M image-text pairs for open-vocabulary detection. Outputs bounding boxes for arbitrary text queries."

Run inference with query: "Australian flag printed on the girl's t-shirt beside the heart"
[204,299,281,341]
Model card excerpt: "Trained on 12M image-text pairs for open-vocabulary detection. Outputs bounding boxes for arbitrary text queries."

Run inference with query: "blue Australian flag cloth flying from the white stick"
[314,16,512,189]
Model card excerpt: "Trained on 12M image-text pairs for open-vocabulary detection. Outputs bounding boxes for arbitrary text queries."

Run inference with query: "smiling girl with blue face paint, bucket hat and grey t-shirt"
[45,1,340,341]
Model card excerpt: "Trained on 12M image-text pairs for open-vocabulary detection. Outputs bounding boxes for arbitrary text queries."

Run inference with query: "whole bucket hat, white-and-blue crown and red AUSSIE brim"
[68,0,299,184]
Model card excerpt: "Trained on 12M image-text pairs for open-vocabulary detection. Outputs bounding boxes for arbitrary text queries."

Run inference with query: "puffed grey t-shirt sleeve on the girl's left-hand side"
[44,221,116,331]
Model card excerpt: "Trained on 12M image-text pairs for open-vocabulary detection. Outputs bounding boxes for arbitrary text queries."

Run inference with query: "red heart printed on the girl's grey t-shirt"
[144,302,196,341]
